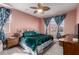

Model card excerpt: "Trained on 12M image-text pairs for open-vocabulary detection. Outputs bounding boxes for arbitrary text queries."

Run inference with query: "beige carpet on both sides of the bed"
[0,42,63,55]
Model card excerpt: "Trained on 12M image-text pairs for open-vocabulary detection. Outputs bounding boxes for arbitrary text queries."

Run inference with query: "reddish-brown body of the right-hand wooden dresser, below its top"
[63,41,79,55]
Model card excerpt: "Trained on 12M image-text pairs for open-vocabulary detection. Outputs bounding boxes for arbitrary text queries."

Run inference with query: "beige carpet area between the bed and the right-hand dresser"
[44,42,63,55]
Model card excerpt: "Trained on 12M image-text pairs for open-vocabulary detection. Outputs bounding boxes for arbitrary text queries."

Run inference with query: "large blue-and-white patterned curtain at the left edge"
[0,7,11,40]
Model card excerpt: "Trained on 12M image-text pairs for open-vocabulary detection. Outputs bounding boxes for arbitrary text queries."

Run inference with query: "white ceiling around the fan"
[3,3,78,18]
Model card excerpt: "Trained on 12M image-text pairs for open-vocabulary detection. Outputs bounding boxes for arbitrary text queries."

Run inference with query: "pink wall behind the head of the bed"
[10,10,41,33]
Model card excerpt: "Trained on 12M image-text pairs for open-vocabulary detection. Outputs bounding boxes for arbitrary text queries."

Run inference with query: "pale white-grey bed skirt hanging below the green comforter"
[20,40,53,55]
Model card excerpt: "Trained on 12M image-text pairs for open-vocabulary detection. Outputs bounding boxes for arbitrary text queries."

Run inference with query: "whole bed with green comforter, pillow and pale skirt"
[20,31,53,55]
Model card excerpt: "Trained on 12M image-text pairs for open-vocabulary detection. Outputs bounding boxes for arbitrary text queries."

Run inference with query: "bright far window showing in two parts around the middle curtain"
[48,18,64,38]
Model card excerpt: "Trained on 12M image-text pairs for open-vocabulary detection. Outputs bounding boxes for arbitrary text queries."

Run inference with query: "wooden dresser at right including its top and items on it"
[59,34,79,55]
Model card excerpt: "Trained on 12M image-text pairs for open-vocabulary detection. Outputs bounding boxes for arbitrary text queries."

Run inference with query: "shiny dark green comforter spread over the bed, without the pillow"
[21,35,53,51]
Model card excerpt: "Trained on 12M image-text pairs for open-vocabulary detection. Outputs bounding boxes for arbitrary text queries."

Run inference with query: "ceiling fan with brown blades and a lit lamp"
[30,3,50,13]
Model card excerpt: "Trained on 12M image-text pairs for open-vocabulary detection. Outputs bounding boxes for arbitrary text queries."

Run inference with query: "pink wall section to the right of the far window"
[64,10,76,34]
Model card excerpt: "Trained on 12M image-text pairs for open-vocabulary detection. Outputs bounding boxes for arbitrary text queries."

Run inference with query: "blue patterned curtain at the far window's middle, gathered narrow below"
[54,15,65,38]
